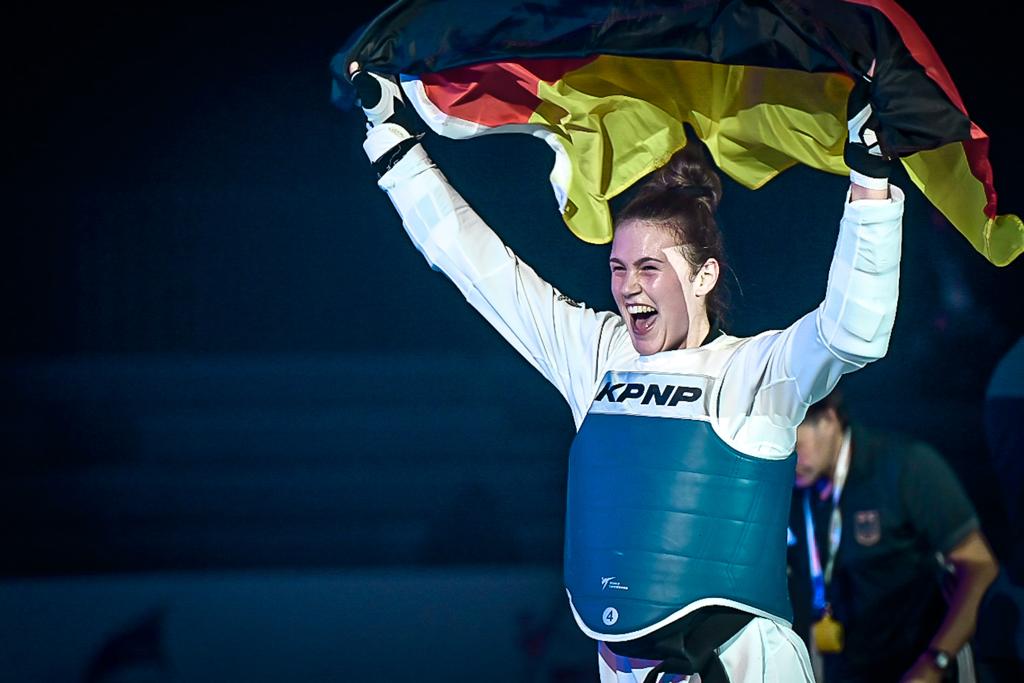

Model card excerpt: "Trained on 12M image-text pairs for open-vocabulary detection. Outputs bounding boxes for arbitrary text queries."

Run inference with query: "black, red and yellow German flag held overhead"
[331,0,1024,265]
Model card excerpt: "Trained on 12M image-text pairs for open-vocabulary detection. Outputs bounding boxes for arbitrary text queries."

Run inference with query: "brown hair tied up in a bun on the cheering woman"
[615,141,728,324]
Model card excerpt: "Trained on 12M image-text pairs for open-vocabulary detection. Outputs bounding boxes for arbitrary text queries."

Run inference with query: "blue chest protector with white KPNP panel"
[564,373,796,640]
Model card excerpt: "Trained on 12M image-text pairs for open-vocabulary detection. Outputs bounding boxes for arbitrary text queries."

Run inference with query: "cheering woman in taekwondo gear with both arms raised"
[350,63,903,683]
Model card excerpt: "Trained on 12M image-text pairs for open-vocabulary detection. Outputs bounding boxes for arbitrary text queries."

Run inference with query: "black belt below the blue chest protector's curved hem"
[605,606,754,683]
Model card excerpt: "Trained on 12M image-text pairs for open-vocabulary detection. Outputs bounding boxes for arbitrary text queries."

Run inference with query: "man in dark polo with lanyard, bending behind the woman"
[790,390,998,683]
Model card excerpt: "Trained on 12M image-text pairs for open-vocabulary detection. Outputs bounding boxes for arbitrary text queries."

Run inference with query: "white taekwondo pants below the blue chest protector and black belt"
[597,616,814,683]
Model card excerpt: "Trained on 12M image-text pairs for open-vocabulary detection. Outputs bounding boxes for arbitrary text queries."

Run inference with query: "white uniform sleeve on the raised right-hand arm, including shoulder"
[718,186,904,457]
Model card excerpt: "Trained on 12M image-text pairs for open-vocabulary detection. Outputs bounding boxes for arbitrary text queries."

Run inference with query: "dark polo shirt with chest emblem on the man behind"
[790,426,978,683]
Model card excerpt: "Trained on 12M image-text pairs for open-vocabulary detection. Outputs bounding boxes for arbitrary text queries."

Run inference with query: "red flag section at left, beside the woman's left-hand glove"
[420,57,597,127]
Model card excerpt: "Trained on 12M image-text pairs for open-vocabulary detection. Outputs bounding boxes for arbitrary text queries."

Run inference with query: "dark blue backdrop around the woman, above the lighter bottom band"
[0,2,1024,679]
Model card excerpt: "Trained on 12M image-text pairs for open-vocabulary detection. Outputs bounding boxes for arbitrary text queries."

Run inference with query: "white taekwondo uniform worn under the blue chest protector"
[368,128,903,683]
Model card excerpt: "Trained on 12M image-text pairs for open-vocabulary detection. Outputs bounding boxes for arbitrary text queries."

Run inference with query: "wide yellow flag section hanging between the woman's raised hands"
[530,56,852,244]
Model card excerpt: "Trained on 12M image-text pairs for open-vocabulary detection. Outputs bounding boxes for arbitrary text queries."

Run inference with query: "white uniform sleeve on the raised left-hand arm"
[370,137,626,425]
